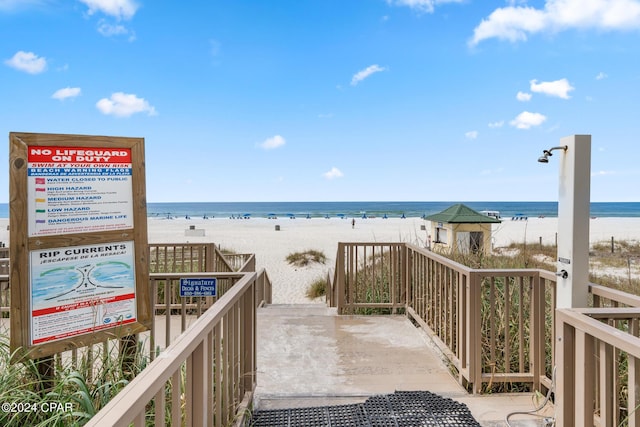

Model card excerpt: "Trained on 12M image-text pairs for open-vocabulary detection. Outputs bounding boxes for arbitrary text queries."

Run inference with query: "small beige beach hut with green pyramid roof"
[425,203,500,254]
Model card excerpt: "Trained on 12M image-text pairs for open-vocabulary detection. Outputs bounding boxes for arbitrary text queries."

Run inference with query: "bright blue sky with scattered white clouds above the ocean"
[0,0,640,203]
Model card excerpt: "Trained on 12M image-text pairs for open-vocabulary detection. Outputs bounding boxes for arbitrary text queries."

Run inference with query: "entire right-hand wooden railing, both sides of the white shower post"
[327,243,640,426]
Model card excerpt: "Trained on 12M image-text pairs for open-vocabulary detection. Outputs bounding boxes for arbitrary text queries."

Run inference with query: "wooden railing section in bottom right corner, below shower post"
[555,308,640,426]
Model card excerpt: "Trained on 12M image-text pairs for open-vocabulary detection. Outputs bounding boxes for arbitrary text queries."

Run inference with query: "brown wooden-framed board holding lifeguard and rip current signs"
[9,132,152,360]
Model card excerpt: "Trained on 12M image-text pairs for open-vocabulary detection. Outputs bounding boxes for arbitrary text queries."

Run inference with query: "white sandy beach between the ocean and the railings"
[0,217,640,303]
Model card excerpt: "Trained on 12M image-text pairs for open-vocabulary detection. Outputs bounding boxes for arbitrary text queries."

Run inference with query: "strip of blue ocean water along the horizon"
[0,201,640,218]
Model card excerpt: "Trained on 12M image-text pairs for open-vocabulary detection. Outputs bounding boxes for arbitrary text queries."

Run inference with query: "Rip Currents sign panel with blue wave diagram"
[30,242,136,344]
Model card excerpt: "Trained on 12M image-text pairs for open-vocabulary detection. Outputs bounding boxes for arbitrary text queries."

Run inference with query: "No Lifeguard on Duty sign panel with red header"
[27,146,133,236]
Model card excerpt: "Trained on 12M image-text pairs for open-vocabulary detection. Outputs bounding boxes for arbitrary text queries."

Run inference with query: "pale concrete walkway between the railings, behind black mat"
[254,304,552,426]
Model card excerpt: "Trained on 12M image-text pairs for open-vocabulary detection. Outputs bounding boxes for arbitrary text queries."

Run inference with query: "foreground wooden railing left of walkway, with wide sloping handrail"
[86,271,265,427]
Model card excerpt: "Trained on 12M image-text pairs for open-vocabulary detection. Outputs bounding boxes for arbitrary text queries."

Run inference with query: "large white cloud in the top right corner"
[469,0,640,46]
